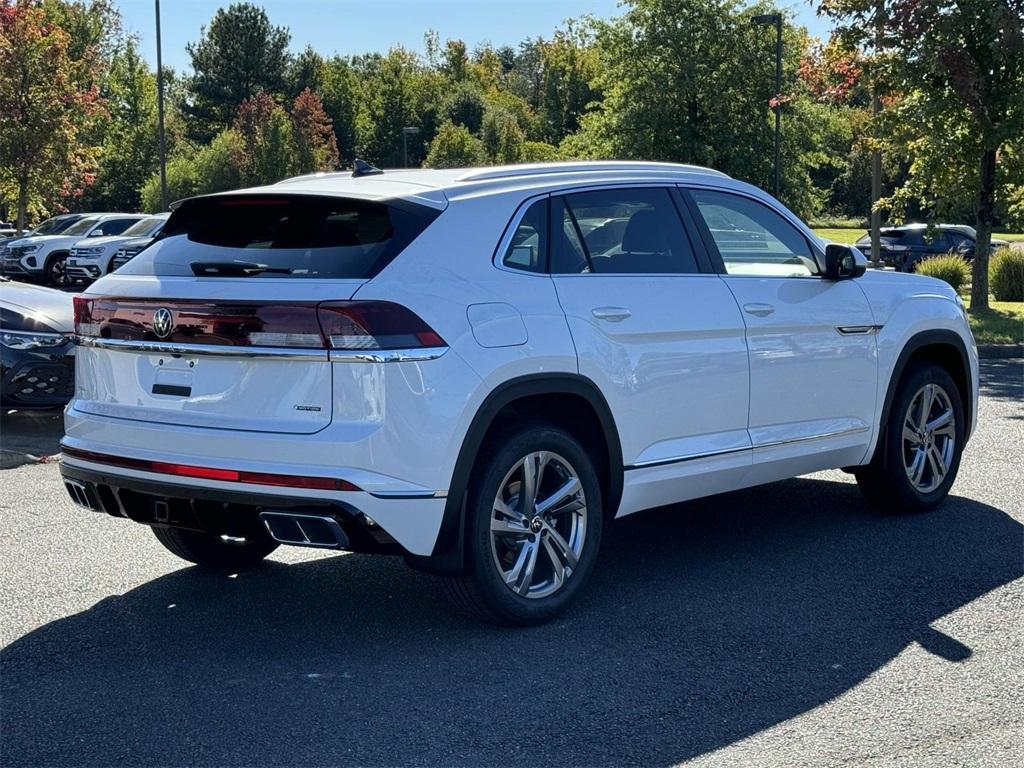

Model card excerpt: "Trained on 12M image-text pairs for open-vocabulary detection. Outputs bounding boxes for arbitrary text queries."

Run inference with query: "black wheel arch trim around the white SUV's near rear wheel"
[407,373,623,573]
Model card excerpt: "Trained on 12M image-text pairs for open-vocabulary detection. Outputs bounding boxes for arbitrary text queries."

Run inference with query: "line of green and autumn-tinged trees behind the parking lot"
[0,0,1024,243]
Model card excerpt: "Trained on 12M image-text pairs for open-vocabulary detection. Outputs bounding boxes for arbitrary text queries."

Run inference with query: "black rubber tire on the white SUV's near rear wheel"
[443,424,604,626]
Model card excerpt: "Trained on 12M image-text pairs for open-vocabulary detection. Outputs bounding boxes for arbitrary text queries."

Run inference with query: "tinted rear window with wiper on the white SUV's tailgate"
[133,196,440,280]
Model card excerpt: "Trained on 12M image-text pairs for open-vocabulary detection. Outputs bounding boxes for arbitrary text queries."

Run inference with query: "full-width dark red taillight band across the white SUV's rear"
[74,296,444,350]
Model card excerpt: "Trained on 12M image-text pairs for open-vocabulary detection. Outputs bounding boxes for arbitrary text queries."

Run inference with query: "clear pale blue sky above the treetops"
[116,0,828,72]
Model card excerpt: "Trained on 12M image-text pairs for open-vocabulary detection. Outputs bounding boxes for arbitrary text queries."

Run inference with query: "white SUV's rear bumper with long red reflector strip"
[60,448,445,555]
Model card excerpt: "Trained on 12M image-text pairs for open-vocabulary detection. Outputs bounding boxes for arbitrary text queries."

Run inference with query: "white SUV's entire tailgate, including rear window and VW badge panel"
[74,195,438,434]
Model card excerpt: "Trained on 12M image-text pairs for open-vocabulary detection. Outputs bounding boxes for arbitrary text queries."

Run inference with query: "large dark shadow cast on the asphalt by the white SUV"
[0,479,1024,766]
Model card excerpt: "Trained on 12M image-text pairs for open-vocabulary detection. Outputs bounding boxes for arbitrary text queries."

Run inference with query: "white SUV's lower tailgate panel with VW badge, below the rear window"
[75,283,361,433]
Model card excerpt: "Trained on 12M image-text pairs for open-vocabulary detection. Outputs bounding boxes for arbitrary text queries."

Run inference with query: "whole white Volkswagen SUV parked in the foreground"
[60,162,978,624]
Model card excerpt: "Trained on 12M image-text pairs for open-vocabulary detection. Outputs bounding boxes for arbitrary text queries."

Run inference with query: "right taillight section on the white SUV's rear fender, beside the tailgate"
[317,301,444,349]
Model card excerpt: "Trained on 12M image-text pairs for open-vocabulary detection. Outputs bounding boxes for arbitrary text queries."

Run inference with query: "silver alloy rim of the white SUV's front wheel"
[902,384,956,494]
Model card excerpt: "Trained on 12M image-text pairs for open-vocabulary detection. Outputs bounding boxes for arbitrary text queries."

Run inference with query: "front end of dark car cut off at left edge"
[0,278,75,409]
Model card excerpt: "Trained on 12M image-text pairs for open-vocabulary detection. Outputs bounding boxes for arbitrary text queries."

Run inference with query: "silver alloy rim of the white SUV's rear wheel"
[490,451,587,599]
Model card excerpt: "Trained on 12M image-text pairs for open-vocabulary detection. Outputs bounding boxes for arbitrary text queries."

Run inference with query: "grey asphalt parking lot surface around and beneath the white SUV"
[0,360,1024,766]
